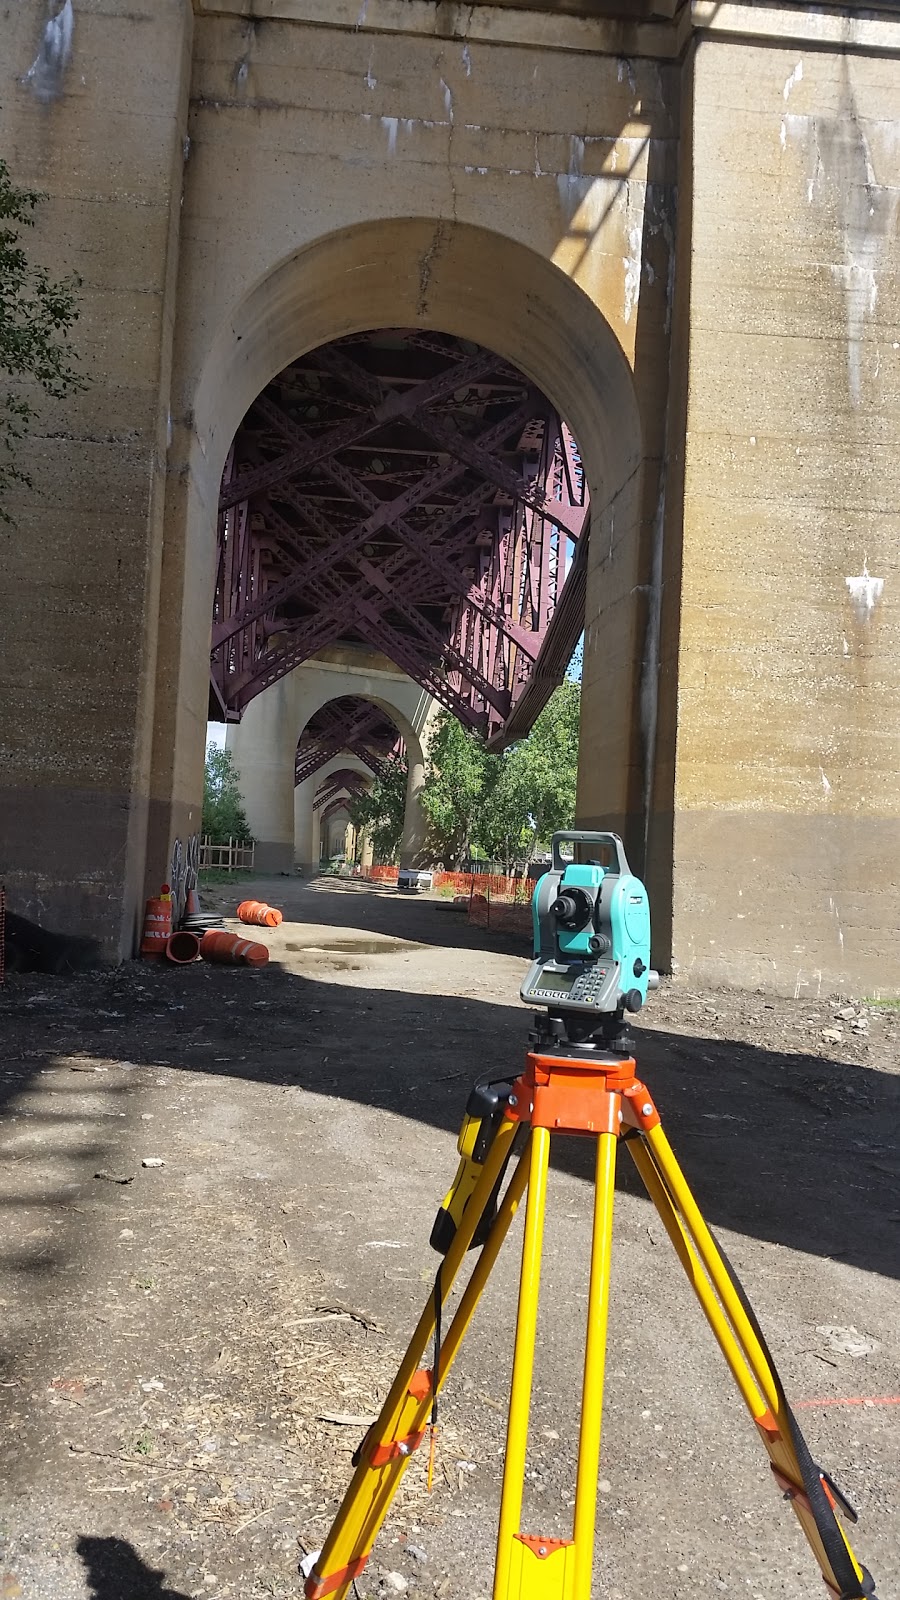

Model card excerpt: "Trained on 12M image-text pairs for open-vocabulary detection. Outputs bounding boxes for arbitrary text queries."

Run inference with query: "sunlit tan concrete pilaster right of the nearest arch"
[674,38,900,994]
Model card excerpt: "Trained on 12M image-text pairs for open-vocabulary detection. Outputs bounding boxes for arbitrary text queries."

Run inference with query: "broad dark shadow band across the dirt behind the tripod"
[0,915,900,1275]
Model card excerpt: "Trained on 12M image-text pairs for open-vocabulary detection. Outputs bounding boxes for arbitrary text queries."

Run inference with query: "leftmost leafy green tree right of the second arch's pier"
[421,712,503,866]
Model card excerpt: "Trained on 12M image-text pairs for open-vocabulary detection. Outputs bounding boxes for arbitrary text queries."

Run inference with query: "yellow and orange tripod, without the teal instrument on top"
[306,1043,874,1600]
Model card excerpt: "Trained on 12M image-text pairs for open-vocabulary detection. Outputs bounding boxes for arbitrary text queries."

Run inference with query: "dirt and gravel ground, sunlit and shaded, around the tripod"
[0,880,900,1600]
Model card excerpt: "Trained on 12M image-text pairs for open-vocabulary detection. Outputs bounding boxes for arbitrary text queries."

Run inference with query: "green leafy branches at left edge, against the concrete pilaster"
[0,160,85,525]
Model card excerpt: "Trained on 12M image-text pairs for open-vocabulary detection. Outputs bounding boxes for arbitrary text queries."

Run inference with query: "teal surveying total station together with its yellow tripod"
[304,832,874,1600]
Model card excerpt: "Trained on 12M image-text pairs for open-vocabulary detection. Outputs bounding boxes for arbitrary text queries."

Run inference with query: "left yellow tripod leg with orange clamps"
[304,1122,528,1600]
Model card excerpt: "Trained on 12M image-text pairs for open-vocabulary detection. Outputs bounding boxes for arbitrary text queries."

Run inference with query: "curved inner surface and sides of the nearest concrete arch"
[151,216,645,915]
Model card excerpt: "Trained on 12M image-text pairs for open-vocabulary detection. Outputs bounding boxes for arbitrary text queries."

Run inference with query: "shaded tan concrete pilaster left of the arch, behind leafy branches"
[0,0,192,954]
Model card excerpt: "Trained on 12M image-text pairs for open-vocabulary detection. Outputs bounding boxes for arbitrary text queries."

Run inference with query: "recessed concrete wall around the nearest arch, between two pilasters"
[157,5,666,928]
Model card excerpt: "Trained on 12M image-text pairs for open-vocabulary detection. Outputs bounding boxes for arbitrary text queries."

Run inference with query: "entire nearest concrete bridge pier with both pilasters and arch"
[0,0,900,992]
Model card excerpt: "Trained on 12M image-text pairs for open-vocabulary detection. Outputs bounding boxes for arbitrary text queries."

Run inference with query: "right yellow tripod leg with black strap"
[628,1123,874,1600]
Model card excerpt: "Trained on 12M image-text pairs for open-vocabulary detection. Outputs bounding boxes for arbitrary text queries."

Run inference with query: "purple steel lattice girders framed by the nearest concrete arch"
[210,330,588,742]
